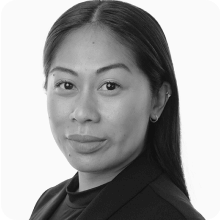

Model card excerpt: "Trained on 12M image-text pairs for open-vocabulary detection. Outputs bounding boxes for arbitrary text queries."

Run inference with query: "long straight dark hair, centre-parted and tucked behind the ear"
[44,0,189,198]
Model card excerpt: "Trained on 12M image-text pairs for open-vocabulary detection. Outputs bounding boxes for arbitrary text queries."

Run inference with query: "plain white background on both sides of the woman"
[1,0,220,220]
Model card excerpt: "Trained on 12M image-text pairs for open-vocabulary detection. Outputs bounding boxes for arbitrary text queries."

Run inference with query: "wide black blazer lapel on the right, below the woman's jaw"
[77,152,162,220]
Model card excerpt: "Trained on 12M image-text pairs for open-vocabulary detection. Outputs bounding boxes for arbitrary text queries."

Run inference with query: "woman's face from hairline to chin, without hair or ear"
[47,27,152,172]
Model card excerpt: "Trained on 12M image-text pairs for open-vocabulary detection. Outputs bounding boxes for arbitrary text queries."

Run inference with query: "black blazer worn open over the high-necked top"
[30,153,204,220]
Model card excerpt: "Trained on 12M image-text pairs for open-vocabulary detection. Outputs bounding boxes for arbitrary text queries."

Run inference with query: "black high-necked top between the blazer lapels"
[50,173,107,220]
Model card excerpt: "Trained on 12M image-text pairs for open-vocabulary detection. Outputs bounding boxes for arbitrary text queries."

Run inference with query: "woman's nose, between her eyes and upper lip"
[69,92,100,124]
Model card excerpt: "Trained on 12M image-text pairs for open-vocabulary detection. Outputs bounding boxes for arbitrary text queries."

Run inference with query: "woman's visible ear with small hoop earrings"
[150,82,172,120]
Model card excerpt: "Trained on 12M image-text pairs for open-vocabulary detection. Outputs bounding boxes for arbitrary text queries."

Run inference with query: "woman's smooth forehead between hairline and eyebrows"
[52,25,134,71]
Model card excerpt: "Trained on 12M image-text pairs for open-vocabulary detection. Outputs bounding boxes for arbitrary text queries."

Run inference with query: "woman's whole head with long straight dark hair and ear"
[44,1,188,199]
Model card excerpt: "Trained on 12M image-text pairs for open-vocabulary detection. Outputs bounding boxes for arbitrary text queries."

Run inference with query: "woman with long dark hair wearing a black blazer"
[30,1,204,220]
